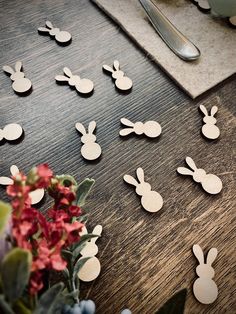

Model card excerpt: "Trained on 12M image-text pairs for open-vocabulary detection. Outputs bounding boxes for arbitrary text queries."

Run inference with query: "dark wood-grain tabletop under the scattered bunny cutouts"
[0,0,236,314]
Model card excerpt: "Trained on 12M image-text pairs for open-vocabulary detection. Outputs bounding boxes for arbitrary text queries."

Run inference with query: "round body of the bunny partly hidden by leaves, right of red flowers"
[78,257,101,282]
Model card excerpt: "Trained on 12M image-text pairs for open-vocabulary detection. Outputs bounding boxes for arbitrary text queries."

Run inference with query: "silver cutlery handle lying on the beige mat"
[139,0,201,61]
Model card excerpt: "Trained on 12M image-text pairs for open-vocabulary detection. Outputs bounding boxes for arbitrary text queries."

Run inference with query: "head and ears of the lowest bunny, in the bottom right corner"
[193,244,217,279]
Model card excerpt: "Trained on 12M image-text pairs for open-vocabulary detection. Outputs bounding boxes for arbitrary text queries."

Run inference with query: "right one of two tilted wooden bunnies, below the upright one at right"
[177,157,222,194]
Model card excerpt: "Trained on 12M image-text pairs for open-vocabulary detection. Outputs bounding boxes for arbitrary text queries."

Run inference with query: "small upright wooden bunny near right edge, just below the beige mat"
[199,105,220,140]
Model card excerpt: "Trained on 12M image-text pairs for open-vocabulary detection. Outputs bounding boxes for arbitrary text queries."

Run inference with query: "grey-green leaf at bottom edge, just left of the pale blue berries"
[34,282,64,314]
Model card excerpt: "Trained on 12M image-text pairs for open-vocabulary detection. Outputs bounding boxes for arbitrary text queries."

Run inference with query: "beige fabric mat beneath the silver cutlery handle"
[92,0,236,98]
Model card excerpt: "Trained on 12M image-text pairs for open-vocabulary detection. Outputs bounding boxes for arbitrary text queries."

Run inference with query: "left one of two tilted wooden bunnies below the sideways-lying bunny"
[123,168,163,213]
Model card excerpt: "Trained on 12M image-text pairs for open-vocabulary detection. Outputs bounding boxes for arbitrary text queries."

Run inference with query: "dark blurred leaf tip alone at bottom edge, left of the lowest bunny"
[156,289,187,314]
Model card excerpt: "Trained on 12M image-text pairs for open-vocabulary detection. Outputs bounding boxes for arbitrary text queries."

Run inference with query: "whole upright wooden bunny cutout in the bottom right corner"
[193,244,218,304]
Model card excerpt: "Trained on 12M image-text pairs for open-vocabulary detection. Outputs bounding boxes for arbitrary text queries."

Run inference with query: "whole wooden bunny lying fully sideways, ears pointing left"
[120,118,161,138]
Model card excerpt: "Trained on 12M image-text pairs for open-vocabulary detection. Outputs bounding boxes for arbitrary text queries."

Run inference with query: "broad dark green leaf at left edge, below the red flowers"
[1,248,32,302]
